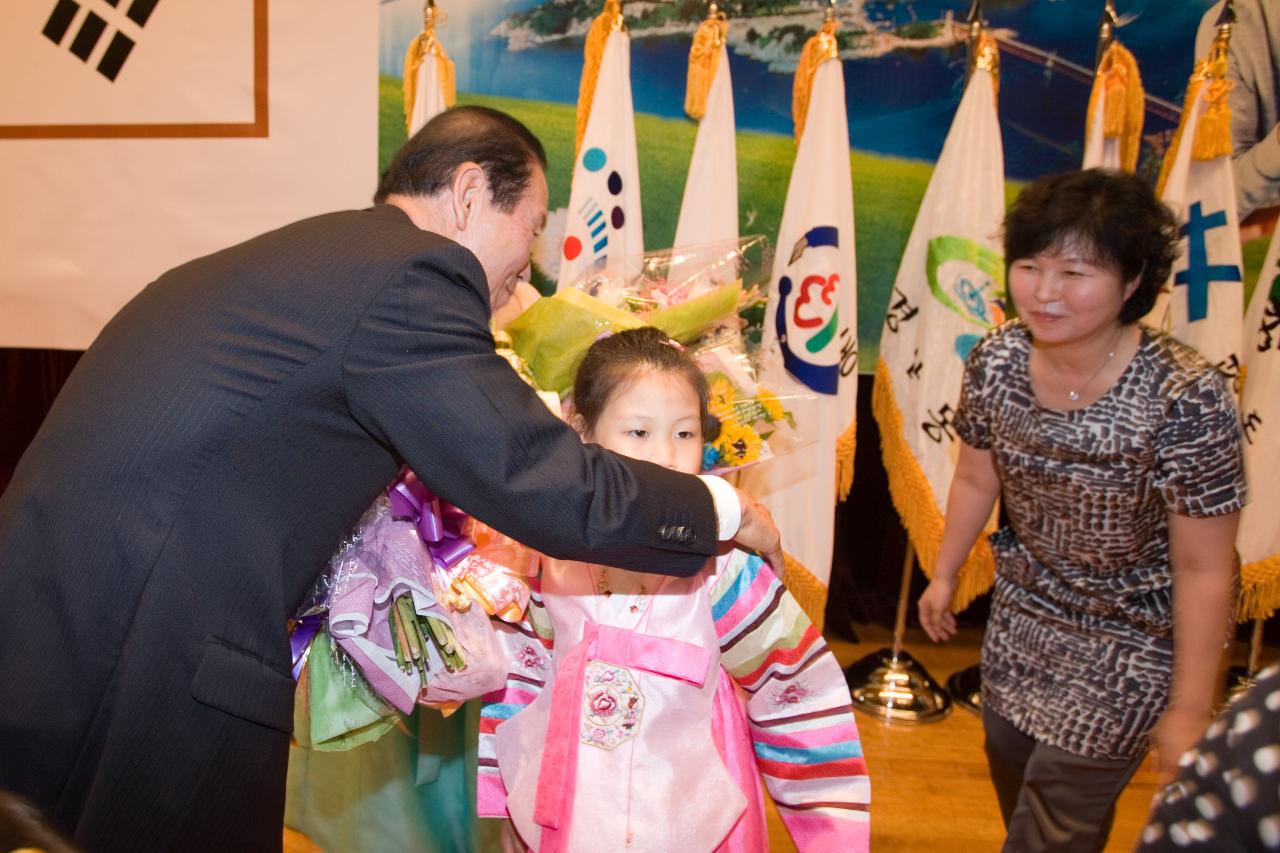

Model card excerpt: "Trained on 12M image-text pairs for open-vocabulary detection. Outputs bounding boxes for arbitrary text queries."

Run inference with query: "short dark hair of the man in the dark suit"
[374,106,547,213]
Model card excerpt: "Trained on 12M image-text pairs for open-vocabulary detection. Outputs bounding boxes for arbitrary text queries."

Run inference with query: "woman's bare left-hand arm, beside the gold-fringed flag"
[919,441,1000,643]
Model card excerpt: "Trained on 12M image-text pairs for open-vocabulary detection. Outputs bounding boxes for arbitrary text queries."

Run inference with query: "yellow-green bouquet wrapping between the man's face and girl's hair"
[507,288,640,394]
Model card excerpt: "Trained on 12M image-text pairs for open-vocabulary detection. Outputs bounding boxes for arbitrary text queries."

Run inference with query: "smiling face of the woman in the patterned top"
[1009,239,1138,343]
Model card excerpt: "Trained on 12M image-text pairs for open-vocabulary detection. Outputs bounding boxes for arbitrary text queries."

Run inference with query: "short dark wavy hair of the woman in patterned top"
[1005,169,1178,324]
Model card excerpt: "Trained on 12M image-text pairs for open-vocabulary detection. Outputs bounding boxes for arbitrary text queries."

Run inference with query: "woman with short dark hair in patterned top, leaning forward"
[919,170,1244,850]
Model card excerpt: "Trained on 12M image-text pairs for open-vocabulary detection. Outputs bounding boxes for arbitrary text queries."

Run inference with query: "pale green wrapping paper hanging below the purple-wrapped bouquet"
[303,630,398,752]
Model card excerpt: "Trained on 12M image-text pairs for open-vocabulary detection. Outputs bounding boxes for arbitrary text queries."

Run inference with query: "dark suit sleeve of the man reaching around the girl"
[343,246,717,576]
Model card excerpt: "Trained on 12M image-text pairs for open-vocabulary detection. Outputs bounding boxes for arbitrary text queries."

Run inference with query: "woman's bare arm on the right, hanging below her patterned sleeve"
[1153,512,1240,781]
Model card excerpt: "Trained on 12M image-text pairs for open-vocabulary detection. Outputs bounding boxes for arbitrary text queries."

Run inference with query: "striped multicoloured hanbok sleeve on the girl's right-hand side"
[712,552,870,853]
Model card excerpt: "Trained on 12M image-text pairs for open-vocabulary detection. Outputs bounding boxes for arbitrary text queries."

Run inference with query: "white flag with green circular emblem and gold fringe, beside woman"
[872,35,1007,608]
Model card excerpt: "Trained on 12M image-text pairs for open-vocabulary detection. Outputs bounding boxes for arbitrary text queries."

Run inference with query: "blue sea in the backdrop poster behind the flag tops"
[380,0,1212,178]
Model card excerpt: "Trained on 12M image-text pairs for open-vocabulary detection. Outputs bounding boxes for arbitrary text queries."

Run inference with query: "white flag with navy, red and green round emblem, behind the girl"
[739,22,858,625]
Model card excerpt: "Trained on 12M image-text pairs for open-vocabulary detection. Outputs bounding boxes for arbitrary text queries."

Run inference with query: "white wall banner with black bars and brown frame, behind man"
[0,0,378,350]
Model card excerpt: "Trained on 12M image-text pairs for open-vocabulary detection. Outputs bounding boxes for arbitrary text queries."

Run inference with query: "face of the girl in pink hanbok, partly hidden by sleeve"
[584,370,703,474]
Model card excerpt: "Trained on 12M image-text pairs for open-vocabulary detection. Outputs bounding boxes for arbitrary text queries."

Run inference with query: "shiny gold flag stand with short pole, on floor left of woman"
[845,537,951,724]
